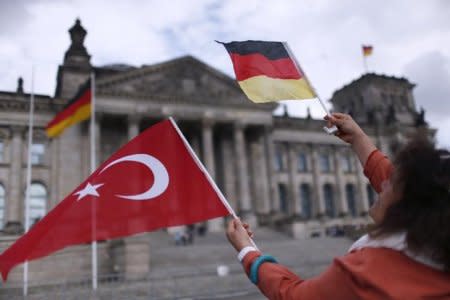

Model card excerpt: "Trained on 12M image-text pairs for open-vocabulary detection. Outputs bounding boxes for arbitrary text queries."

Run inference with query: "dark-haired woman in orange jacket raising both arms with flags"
[227,113,450,300]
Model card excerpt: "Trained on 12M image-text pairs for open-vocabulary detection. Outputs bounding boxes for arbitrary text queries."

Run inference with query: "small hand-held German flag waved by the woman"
[219,41,316,103]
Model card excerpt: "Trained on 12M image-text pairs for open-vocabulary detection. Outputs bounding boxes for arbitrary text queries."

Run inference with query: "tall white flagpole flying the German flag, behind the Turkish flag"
[90,72,98,291]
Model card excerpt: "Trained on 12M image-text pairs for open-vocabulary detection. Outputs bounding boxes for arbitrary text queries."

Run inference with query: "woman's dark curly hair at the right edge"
[371,135,450,271]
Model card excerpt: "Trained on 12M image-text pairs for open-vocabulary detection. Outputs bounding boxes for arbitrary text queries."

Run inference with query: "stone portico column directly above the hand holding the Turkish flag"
[233,123,256,227]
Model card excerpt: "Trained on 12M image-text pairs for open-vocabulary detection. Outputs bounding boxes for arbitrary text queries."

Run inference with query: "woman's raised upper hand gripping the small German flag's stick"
[324,113,365,144]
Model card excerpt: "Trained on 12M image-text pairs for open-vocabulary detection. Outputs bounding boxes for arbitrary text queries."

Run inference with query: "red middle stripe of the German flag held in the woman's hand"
[230,53,303,81]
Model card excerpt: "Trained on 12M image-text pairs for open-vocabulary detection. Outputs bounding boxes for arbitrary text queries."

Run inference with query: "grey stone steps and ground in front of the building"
[0,228,351,300]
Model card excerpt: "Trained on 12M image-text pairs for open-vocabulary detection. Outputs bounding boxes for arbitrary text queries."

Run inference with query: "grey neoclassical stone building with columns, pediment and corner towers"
[0,20,435,237]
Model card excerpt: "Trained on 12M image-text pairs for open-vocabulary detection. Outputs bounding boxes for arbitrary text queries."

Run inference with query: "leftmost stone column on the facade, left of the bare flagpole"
[4,126,25,234]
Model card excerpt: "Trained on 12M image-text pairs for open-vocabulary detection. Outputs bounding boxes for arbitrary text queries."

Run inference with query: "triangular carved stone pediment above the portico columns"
[96,56,274,109]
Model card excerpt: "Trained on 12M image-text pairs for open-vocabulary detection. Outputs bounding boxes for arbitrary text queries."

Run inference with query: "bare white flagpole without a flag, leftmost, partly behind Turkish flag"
[23,64,34,296]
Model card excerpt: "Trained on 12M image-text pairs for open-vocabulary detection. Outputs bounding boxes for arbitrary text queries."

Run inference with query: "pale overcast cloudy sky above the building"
[0,0,450,147]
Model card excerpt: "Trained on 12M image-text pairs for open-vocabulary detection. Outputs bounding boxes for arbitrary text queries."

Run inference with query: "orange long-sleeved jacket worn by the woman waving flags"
[242,150,450,300]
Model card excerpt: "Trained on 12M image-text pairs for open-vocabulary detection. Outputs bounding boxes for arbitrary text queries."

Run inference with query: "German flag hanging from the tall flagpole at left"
[45,80,92,138]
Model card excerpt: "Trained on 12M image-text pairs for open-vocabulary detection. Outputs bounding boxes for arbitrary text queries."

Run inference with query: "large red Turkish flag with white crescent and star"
[0,120,229,280]
